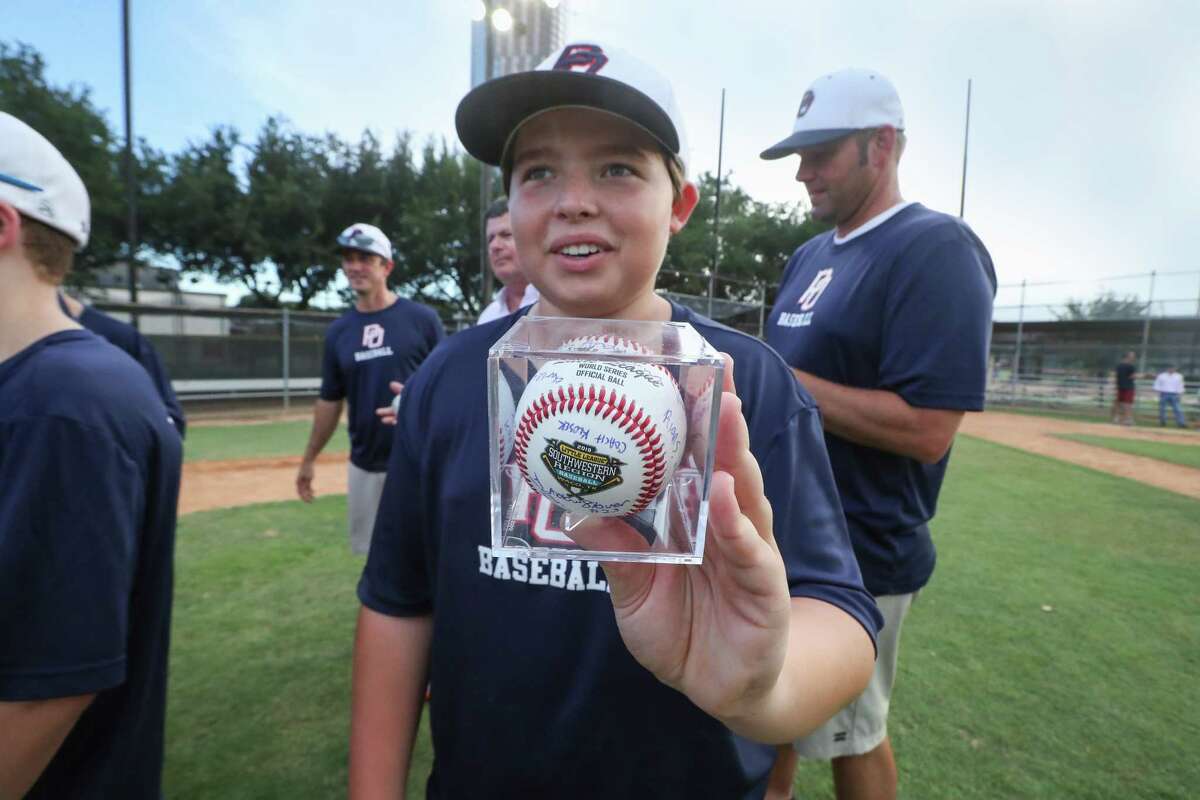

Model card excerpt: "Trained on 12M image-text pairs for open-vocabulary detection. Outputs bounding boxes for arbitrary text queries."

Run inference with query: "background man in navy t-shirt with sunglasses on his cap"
[296,223,445,554]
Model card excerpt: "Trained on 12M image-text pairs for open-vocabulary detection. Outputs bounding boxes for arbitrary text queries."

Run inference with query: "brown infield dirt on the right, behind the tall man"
[961,411,1200,499]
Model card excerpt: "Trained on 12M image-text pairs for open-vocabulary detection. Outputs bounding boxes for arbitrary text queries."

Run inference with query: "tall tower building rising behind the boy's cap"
[470,0,566,86]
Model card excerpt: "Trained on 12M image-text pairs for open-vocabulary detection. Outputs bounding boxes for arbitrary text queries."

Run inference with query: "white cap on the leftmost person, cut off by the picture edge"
[0,112,91,249]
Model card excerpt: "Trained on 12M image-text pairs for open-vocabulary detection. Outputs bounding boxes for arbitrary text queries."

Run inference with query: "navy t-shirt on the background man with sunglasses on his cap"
[320,297,445,473]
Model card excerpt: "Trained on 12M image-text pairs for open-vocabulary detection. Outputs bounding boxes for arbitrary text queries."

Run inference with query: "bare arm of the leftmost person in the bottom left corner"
[0,694,96,798]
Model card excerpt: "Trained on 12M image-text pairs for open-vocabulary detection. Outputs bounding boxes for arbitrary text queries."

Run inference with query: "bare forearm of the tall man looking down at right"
[792,368,964,464]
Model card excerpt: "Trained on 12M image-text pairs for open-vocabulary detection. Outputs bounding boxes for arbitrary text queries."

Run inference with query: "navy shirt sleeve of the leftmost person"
[0,417,145,700]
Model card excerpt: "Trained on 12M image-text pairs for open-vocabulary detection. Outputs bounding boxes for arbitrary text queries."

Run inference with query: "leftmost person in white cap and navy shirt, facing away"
[0,113,181,800]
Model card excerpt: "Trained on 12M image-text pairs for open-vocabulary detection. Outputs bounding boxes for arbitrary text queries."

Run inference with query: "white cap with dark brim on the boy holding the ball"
[455,40,688,174]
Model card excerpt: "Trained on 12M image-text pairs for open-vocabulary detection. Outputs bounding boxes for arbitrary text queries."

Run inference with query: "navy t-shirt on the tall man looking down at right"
[767,203,996,595]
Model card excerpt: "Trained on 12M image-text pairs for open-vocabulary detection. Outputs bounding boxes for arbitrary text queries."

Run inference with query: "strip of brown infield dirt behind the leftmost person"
[179,453,347,513]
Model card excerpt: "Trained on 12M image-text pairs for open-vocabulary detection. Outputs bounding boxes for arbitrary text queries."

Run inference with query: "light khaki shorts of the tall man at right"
[792,593,917,759]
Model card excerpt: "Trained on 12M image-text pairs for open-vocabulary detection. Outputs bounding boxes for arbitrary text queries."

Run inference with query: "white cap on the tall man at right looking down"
[761,70,904,161]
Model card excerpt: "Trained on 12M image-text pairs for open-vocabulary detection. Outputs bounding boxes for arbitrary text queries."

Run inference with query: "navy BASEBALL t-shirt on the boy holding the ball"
[359,306,882,800]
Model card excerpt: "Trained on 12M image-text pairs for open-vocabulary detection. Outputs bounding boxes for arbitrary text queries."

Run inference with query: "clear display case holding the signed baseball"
[487,317,725,564]
